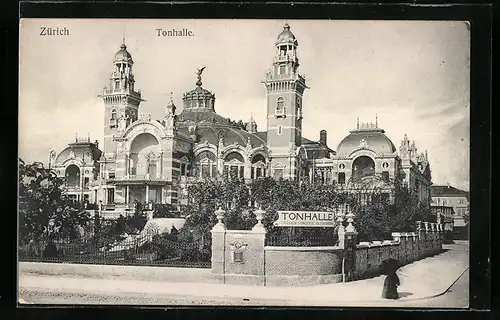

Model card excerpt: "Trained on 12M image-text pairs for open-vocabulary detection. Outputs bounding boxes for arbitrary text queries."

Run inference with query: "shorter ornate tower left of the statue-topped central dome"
[102,43,143,154]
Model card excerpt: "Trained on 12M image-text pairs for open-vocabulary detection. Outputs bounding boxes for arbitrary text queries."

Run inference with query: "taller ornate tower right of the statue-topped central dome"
[263,24,308,179]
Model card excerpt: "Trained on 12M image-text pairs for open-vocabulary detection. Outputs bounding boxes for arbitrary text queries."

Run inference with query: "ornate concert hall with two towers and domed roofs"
[50,24,431,216]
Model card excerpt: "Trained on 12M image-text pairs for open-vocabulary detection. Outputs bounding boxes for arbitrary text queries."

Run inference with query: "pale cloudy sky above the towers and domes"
[19,19,470,190]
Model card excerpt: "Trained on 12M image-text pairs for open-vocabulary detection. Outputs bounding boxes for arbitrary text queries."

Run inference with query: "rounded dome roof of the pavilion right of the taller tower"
[337,128,396,156]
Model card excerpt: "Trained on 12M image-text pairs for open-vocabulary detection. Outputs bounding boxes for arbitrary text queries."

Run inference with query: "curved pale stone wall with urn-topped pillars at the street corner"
[211,209,443,286]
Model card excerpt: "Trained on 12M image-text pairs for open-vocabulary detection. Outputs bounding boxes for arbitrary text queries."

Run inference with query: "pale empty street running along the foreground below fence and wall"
[20,243,469,308]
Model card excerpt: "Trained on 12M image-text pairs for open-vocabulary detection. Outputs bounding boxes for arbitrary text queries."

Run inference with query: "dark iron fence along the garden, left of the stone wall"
[18,233,211,268]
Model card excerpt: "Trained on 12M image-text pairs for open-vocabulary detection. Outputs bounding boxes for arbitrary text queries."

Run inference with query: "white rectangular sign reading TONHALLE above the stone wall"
[274,211,335,228]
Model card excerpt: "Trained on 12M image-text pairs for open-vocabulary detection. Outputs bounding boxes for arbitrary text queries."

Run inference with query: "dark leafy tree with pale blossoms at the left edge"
[18,159,90,242]
